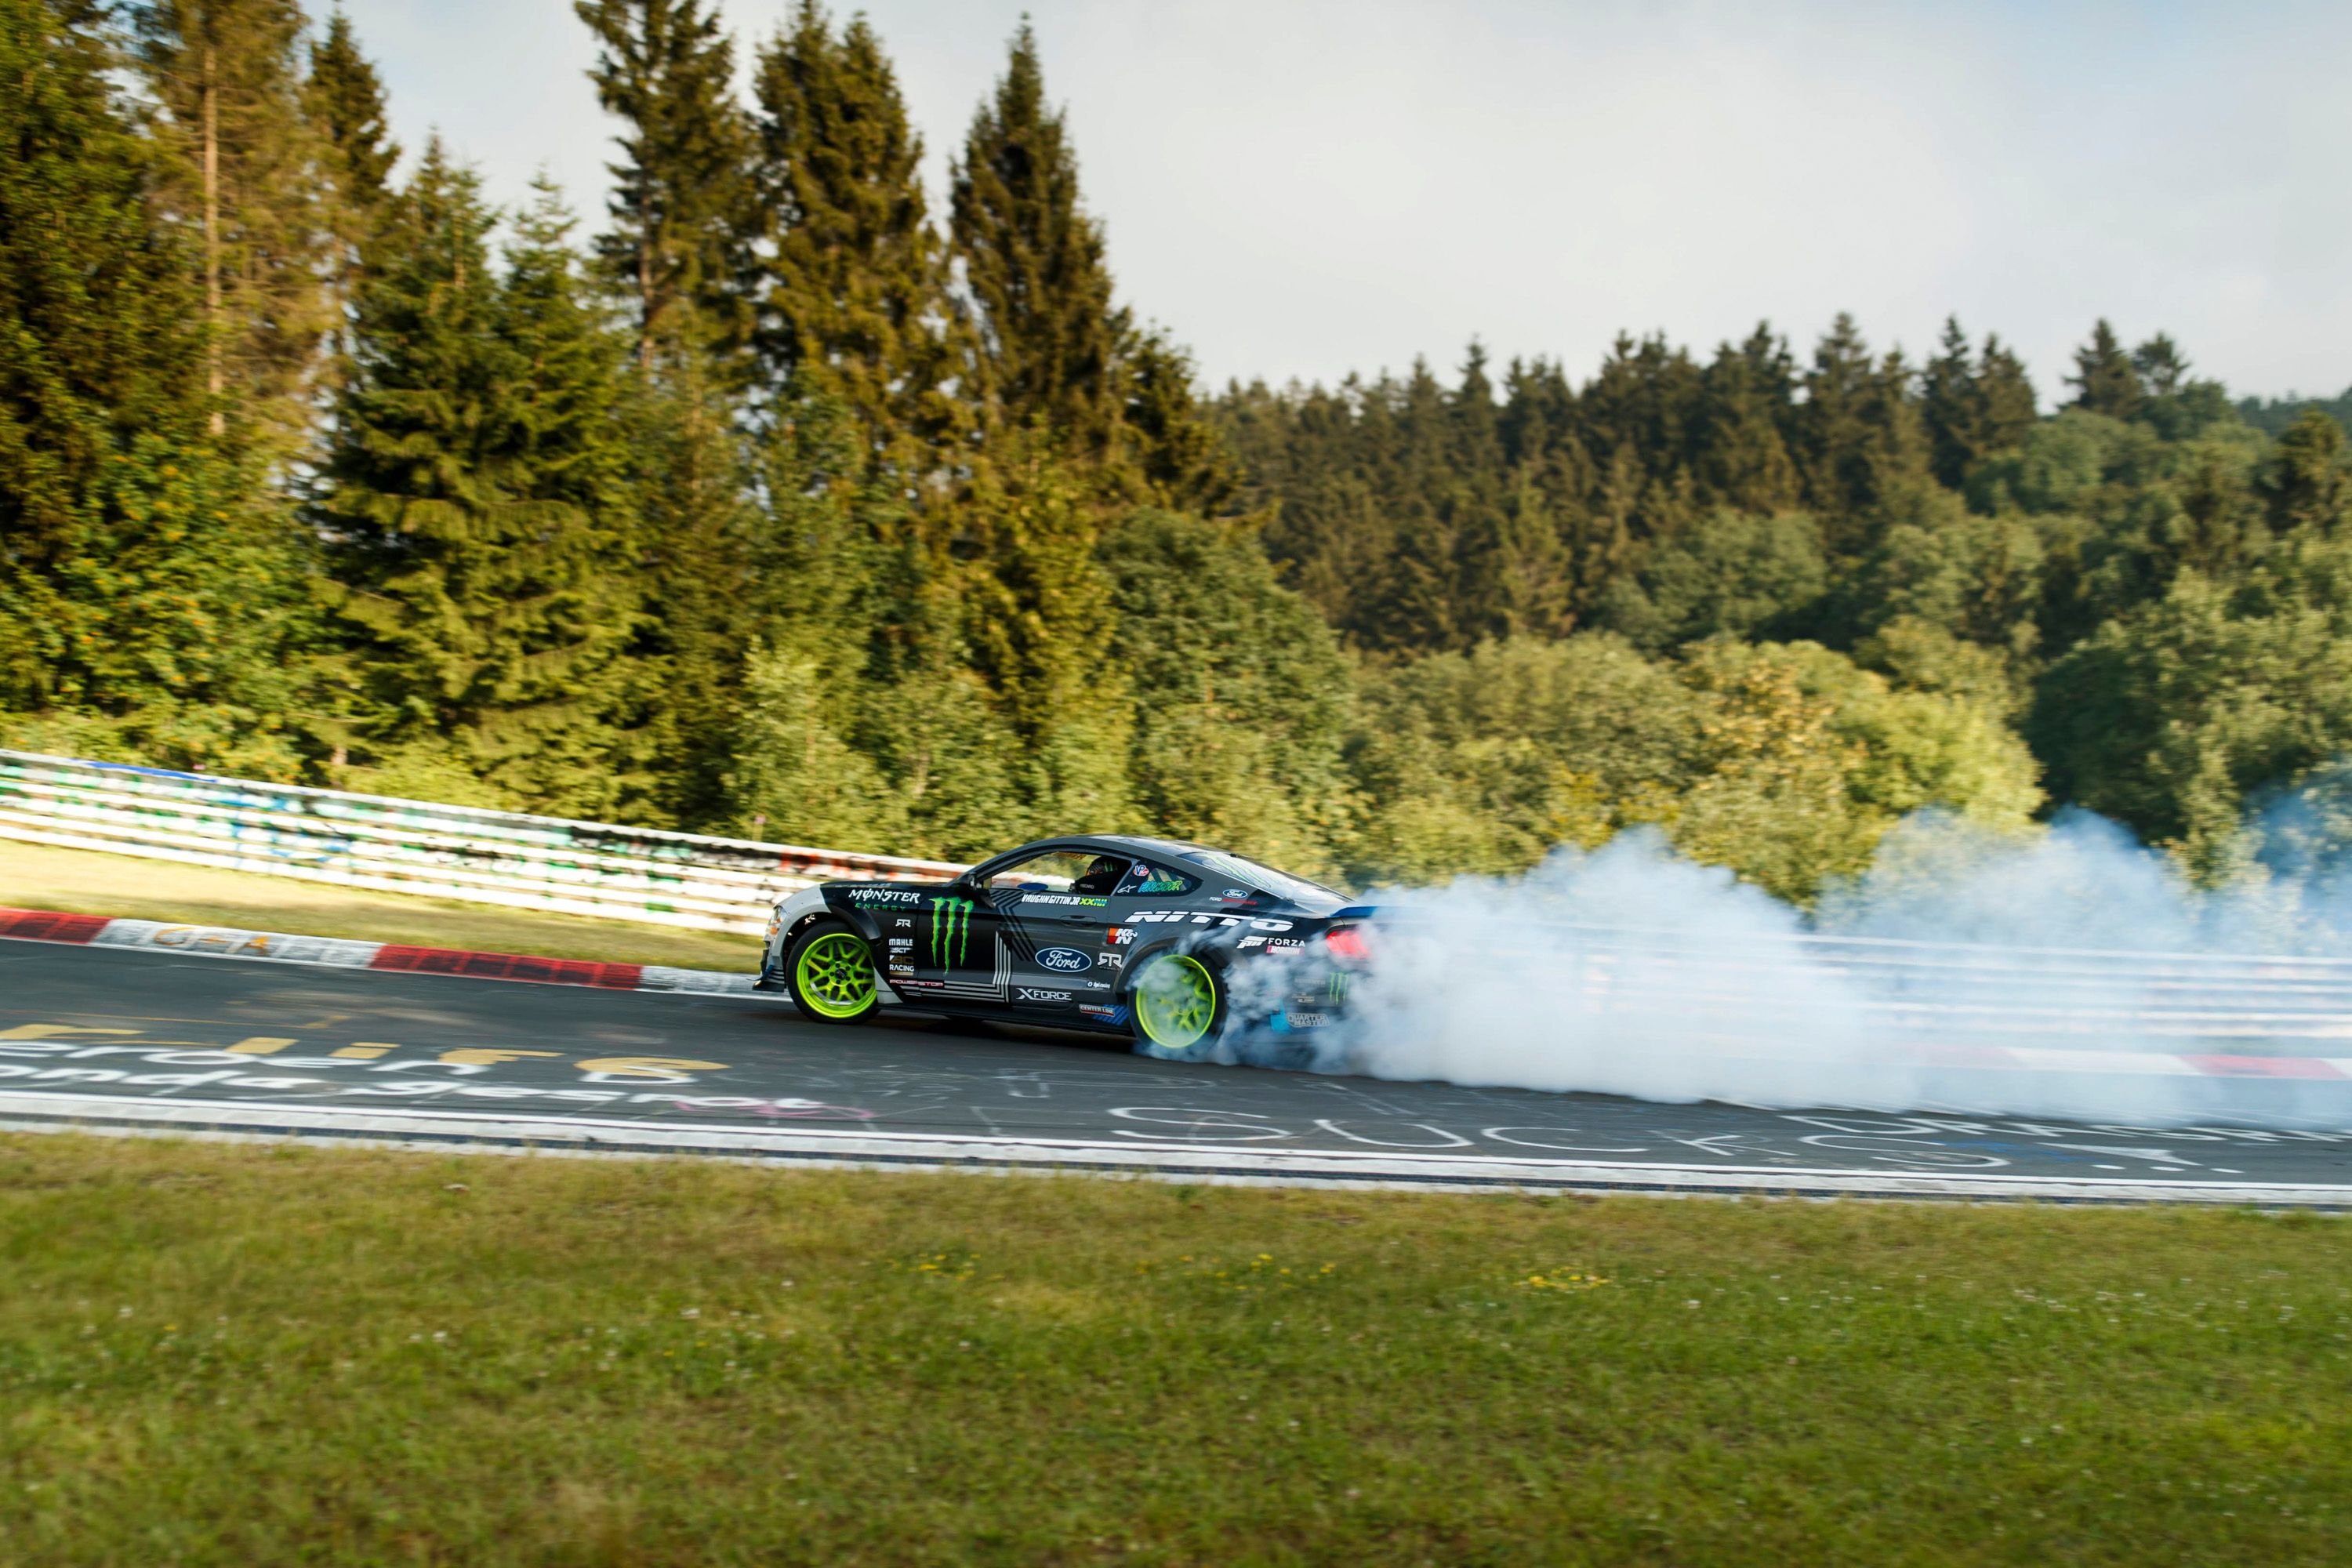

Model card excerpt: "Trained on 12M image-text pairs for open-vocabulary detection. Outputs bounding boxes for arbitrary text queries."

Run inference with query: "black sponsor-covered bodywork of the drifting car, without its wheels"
[760,834,1367,1034]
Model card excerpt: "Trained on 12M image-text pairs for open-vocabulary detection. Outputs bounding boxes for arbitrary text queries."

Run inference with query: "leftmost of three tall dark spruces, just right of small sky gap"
[572,0,750,369]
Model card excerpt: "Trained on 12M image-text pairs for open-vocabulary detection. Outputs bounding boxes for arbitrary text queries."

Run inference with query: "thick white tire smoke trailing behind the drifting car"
[1261,813,2352,1128]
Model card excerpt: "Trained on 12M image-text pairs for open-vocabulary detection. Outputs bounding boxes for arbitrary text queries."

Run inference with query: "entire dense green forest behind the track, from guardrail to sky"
[0,0,2352,900]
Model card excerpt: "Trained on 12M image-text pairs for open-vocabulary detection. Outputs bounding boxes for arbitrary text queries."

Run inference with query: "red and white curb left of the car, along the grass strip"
[0,909,755,994]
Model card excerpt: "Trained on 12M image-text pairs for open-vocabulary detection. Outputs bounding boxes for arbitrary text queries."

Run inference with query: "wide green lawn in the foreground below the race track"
[0,1135,2352,1568]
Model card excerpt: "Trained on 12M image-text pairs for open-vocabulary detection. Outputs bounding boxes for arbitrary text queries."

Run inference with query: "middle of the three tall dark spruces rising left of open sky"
[748,0,971,482]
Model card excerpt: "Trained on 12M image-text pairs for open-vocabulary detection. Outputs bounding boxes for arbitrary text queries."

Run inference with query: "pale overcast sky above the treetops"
[341,0,2352,402]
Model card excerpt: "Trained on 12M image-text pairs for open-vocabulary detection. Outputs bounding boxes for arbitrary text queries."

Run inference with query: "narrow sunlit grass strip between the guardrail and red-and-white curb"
[0,839,760,973]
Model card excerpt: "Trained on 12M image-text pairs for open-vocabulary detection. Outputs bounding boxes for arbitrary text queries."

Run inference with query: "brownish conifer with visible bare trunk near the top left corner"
[134,0,334,454]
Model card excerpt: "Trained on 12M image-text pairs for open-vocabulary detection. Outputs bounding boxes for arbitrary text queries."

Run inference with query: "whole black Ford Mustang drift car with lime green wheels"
[757,837,1374,1060]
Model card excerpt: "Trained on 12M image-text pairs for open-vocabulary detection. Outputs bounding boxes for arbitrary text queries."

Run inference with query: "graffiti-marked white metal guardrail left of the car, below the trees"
[0,750,964,931]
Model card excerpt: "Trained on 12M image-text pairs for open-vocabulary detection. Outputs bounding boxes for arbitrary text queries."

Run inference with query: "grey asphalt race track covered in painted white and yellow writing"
[0,940,2352,1208]
